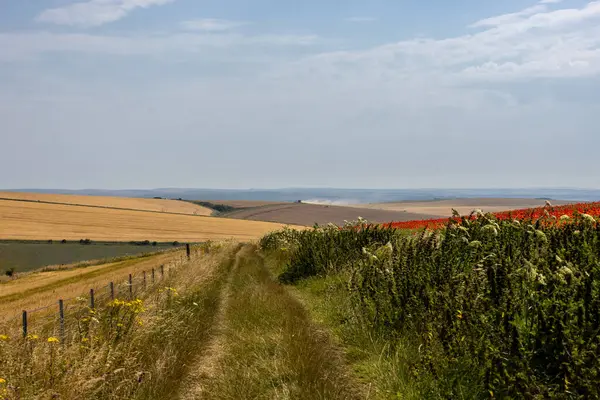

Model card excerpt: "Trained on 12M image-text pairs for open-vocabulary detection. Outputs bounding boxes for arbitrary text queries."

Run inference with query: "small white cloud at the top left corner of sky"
[36,0,175,27]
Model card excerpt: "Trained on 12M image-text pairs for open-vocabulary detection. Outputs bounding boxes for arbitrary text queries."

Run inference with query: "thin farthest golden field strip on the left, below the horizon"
[0,192,212,215]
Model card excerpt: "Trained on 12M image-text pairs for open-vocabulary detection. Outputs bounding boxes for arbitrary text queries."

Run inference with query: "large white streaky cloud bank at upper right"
[284,1,600,83]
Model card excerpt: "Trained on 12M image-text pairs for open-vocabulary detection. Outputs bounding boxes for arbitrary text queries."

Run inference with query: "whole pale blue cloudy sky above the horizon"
[0,0,600,189]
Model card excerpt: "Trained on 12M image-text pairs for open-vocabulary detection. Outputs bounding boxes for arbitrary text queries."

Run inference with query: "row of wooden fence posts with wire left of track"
[0,244,192,343]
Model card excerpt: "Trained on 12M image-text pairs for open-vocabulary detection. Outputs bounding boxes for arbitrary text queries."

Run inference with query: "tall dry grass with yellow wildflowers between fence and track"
[0,245,235,399]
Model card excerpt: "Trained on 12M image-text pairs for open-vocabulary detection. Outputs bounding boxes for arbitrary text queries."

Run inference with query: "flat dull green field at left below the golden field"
[0,241,173,274]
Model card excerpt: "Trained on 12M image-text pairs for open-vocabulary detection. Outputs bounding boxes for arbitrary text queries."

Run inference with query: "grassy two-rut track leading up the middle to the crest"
[173,246,365,400]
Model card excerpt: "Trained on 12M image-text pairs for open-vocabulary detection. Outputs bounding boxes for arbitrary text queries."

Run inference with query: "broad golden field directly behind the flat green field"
[0,200,296,242]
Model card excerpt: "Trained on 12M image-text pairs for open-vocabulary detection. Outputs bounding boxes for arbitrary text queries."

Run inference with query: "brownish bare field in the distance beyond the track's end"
[220,203,435,226]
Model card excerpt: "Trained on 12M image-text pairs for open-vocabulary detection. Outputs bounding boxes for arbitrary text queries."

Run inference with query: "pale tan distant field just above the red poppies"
[352,199,571,217]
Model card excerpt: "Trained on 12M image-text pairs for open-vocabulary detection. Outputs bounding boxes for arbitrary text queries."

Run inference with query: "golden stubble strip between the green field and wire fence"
[0,250,185,321]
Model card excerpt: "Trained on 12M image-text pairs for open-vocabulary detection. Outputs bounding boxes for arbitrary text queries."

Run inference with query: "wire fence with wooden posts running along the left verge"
[0,245,196,342]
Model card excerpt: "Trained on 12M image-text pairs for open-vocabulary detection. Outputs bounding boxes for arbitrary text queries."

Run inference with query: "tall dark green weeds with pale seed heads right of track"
[264,215,600,398]
